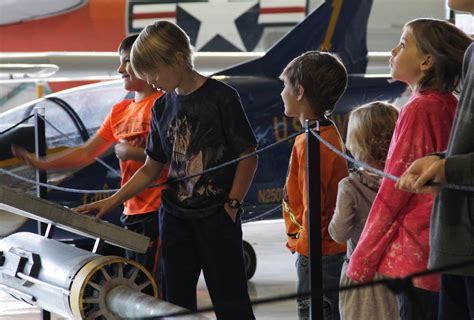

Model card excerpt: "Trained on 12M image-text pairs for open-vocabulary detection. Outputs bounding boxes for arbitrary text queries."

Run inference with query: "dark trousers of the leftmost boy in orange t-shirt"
[120,211,161,278]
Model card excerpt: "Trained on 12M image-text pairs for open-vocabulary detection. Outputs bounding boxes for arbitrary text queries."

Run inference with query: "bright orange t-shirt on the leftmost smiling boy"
[97,92,168,215]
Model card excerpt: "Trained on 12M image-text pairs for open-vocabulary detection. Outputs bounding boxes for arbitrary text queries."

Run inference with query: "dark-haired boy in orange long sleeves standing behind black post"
[280,51,348,320]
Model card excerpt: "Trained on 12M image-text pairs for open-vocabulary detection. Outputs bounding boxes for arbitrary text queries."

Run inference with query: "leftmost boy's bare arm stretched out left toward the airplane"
[12,135,113,170]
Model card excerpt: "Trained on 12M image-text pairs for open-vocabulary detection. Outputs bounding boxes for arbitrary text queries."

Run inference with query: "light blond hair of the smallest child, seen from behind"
[346,101,398,168]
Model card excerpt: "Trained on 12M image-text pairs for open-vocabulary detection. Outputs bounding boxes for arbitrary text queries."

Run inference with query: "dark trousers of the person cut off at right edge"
[438,274,474,320]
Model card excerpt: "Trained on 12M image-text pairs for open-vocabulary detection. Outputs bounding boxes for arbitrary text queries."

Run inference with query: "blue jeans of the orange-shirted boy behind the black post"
[296,252,346,320]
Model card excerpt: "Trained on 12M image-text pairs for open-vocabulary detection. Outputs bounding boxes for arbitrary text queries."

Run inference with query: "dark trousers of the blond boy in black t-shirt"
[160,207,255,320]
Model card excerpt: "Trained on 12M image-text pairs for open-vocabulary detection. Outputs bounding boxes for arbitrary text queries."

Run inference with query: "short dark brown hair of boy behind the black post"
[280,51,347,118]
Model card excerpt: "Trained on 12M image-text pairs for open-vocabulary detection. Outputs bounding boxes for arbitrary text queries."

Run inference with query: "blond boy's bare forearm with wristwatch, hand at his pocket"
[224,148,258,222]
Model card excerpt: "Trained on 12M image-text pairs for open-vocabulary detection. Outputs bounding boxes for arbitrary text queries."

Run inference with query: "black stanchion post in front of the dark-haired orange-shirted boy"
[305,120,323,320]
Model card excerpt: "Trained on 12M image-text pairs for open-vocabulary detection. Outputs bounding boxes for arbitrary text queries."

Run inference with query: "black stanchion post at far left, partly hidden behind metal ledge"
[35,107,52,320]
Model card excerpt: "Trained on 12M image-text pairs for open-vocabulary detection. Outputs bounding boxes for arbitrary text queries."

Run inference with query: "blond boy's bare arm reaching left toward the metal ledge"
[74,157,164,219]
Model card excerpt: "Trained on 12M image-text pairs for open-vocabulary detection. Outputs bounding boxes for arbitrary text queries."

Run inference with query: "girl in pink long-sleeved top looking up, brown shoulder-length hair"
[347,19,472,320]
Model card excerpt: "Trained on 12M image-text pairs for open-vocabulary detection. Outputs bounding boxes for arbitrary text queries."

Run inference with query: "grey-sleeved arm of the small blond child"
[328,178,356,243]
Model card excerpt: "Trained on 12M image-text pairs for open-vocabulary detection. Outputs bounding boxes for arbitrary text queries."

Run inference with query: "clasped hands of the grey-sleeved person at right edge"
[395,155,446,194]
